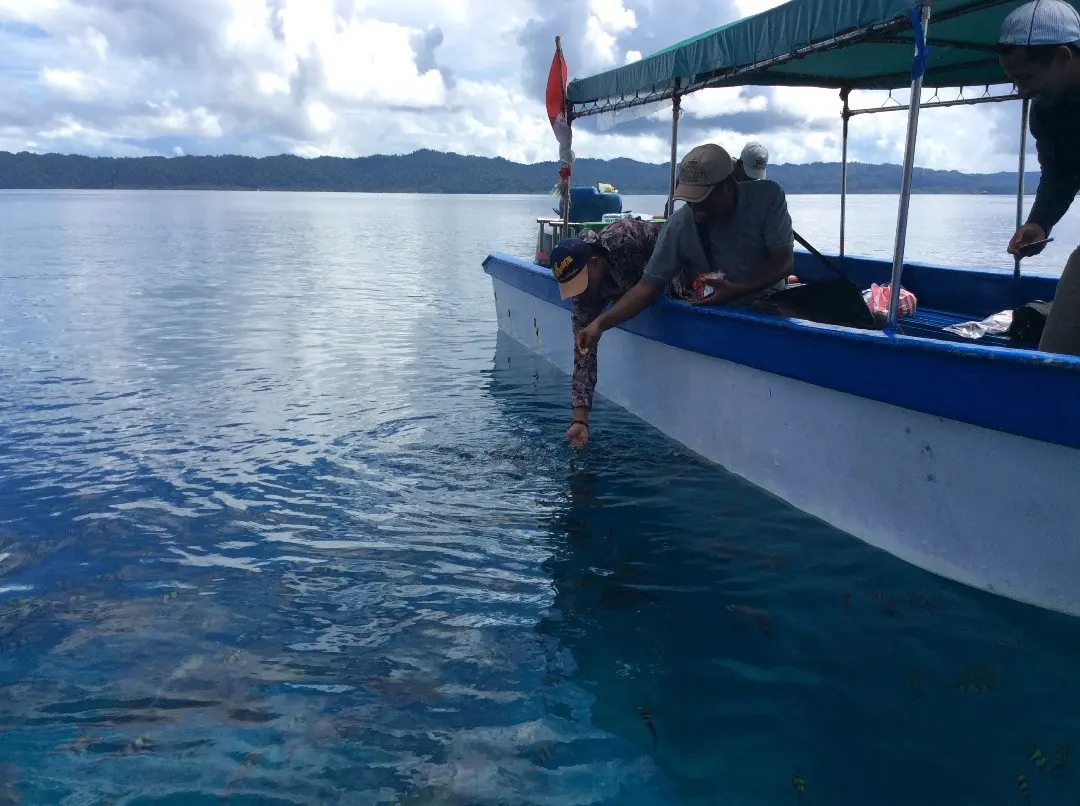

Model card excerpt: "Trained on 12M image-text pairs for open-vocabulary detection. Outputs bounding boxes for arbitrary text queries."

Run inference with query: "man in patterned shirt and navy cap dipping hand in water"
[551,218,660,447]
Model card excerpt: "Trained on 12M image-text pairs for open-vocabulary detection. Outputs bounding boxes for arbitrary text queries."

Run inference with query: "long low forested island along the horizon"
[0,149,1039,194]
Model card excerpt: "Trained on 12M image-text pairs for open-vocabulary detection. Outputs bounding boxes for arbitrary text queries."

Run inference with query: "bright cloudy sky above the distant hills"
[0,0,1036,173]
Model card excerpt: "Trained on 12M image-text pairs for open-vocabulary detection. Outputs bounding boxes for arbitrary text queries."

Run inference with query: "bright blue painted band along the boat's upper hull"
[484,253,1080,451]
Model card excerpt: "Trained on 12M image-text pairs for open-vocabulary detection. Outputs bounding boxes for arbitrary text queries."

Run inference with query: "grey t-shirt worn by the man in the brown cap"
[644,179,795,285]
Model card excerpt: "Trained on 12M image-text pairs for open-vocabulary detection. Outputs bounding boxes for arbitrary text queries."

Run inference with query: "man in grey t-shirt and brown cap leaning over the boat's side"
[577,143,795,353]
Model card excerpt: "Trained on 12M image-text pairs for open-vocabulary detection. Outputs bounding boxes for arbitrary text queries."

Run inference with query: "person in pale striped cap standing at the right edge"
[998,0,1080,355]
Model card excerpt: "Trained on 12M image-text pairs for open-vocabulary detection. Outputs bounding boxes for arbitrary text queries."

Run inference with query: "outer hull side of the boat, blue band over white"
[485,250,1080,615]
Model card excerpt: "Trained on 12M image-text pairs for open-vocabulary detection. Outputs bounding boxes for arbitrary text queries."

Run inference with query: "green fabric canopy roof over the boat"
[567,0,1080,118]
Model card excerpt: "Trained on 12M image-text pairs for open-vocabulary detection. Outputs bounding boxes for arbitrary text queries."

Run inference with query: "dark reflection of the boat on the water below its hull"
[492,338,1080,804]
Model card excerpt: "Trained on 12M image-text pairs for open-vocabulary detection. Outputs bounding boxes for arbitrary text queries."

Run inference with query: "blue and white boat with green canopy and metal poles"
[484,0,1080,616]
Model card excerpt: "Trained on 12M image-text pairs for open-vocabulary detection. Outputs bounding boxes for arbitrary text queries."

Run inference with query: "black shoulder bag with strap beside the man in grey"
[680,221,885,331]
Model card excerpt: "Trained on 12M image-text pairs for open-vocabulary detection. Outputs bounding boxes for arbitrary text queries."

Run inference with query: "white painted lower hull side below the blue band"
[492,278,1080,616]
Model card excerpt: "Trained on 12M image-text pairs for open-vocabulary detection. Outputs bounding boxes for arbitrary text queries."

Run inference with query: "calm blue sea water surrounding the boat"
[0,193,1080,806]
